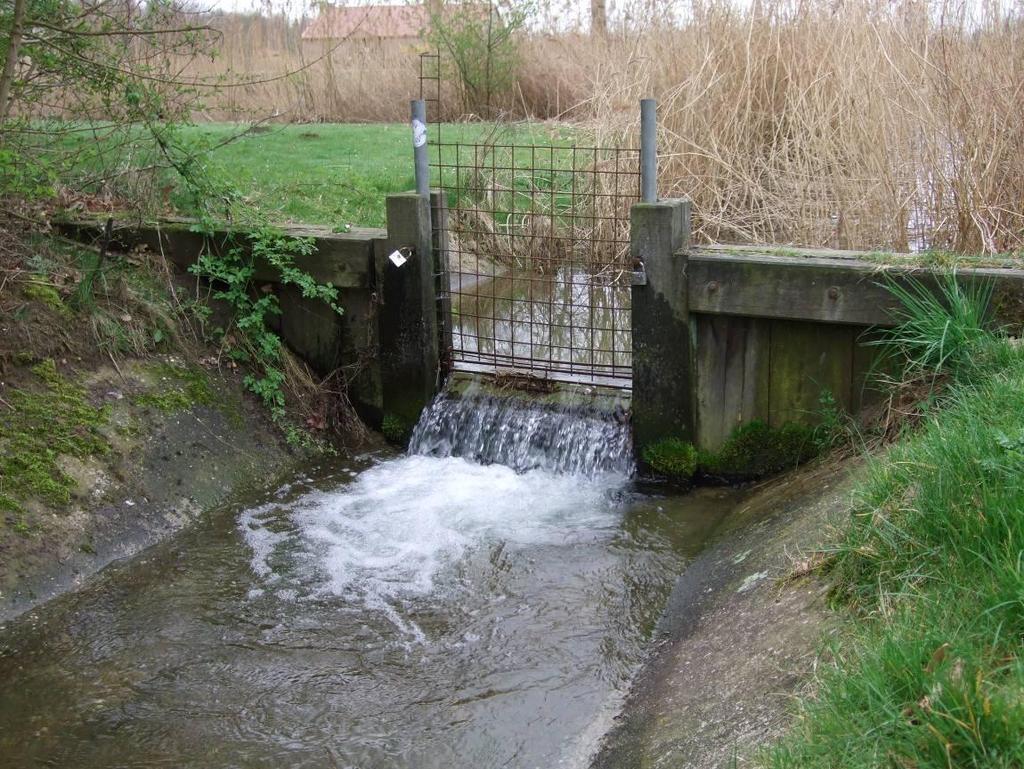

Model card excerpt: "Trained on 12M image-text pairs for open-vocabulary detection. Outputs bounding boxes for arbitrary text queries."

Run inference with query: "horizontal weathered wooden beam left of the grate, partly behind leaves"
[54,219,387,289]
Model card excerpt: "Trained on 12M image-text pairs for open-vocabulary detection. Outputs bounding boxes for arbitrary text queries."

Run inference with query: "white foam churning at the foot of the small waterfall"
[240,456,626,640]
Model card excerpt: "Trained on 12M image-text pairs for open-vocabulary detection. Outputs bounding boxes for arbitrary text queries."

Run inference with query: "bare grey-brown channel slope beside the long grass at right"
[593,462,857,769]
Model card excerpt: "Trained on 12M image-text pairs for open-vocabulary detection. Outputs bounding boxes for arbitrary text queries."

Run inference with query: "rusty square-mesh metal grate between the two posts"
[421,54,640,387]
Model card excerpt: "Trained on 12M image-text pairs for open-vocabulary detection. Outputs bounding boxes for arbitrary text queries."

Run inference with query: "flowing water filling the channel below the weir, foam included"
[0,399,735,769]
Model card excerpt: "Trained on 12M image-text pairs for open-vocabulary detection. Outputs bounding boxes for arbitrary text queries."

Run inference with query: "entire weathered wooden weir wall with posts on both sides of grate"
[60,191,1024,466]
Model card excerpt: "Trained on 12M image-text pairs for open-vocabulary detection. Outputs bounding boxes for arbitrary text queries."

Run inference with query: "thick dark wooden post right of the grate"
[630,200,695,458]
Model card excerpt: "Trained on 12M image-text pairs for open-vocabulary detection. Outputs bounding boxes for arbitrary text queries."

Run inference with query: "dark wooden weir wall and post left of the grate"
[56,193,443,432]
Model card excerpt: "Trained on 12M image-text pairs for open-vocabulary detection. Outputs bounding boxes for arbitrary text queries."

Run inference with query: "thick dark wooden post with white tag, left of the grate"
[375,193,438,437]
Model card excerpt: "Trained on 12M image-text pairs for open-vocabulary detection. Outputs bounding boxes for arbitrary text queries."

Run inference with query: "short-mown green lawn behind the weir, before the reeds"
[39,121,590,229]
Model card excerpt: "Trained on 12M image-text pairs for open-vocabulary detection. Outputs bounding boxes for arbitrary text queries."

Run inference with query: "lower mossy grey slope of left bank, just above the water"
[0,356,296,621]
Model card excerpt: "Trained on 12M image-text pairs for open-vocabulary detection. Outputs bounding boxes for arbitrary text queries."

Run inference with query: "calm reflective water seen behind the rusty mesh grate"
[452,267,633,378]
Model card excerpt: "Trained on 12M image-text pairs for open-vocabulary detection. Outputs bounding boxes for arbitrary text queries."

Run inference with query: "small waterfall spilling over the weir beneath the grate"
[409,379,633,476]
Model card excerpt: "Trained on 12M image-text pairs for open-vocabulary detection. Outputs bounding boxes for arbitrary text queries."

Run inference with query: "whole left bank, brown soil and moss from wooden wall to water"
[0,229,307,618]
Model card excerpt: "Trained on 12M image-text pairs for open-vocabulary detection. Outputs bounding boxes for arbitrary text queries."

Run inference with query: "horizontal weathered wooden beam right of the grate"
[687,248,1024,327]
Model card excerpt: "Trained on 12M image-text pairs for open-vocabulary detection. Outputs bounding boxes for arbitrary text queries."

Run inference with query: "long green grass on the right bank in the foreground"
[765,286,1024,769]
